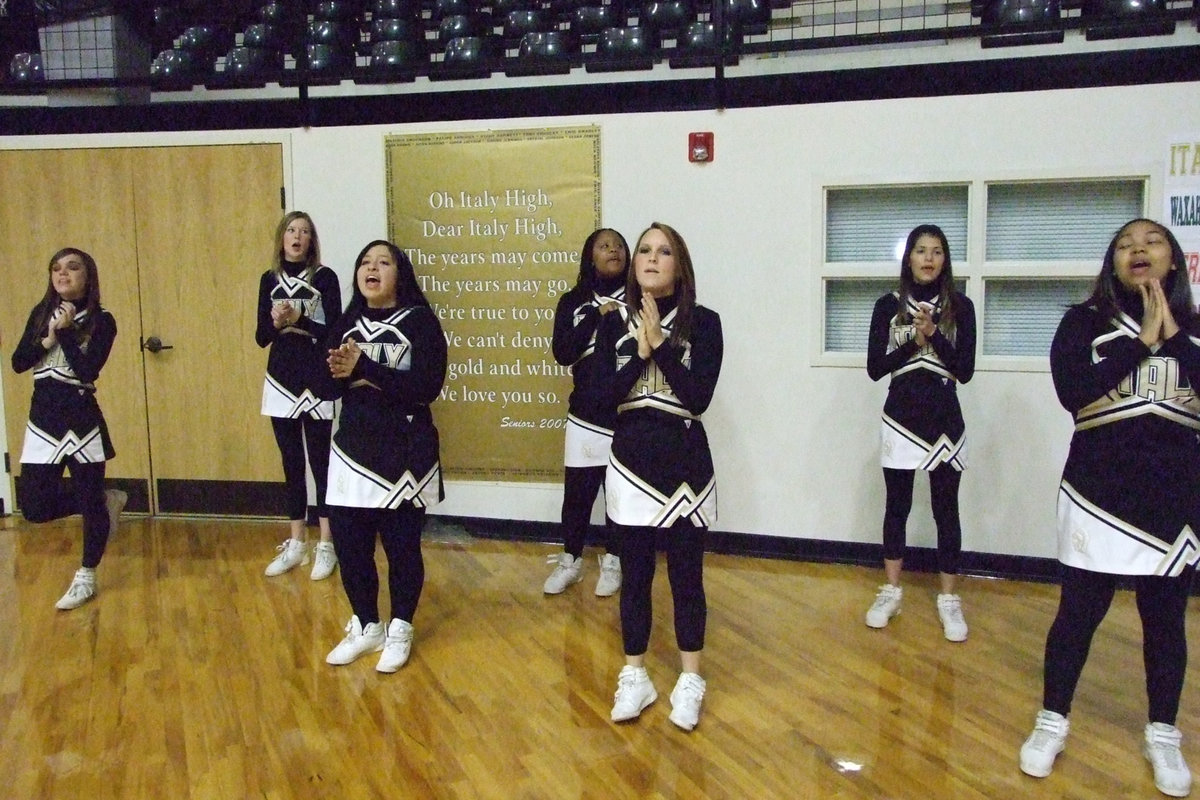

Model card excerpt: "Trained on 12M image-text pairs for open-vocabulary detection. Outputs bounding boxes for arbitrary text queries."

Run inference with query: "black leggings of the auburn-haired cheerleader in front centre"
[616,521,708,656]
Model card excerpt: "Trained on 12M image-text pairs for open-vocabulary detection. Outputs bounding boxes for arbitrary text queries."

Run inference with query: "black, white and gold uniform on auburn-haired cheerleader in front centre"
[596,296,724,528]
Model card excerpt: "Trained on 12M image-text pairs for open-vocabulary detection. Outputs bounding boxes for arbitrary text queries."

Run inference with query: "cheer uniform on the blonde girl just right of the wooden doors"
[254,261,342,420]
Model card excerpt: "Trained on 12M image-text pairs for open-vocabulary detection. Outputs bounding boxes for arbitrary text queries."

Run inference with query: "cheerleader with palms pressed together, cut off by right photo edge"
[1020,219,1200,798]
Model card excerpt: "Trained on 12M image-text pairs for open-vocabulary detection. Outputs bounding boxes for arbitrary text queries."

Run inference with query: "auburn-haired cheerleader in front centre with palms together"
[595,222,724,730]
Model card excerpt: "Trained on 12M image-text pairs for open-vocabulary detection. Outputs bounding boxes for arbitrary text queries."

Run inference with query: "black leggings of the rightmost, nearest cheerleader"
[1042,566,1194,724]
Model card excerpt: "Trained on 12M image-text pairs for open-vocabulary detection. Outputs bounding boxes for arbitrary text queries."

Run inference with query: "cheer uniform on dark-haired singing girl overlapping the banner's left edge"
[323,306,446,509]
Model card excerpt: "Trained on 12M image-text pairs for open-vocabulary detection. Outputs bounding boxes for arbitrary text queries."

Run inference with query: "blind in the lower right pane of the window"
[983,278,1094,356]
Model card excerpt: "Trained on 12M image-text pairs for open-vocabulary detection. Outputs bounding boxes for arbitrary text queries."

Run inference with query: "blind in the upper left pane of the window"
[826,184,967,265]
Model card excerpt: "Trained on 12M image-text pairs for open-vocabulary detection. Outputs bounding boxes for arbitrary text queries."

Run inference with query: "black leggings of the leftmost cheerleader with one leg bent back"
[20,462,109,567]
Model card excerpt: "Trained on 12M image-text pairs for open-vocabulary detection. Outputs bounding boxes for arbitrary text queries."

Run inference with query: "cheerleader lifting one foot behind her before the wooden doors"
[12,247,128,610]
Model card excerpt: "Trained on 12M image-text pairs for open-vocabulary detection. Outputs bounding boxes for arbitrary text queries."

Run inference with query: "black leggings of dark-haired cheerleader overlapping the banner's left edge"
[329,503,425,625]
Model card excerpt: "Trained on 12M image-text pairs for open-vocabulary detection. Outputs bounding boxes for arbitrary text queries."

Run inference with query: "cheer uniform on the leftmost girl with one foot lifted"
[12,307,116,464]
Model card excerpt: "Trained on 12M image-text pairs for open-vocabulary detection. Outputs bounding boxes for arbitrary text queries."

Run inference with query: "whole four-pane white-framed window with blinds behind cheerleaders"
[822,176,1146,368]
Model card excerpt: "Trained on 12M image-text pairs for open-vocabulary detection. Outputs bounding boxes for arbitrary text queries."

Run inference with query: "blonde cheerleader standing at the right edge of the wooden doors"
[254,211,342,581]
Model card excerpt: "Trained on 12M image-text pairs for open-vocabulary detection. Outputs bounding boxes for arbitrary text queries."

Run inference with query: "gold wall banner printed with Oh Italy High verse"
[384,126,600,482]
